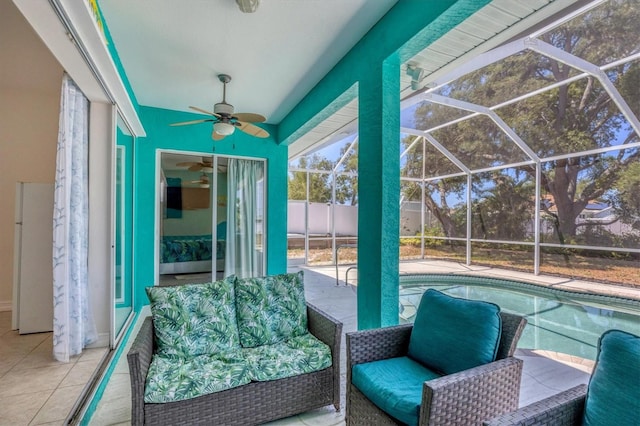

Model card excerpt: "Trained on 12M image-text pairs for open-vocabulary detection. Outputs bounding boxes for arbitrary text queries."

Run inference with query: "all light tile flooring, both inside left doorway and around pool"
[0,261,640,426]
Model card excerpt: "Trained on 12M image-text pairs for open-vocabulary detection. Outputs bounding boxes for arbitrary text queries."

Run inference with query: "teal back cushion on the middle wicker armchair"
[408,289,502,374]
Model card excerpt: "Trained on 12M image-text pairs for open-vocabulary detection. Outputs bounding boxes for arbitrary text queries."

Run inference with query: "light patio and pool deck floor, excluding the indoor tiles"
[85,261,640,426]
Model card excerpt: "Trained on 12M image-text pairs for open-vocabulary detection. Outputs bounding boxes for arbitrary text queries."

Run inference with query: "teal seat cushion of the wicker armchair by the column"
[351,357,440,425]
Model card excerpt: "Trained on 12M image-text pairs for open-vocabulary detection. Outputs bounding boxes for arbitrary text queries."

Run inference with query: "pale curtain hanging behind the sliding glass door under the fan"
[224,158,264,278]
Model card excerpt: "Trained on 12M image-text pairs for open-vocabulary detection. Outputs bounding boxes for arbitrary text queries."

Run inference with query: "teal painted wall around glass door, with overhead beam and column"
[107,0,496,322]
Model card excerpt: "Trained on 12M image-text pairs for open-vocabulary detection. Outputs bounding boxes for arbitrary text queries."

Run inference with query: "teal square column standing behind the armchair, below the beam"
[358,58,400,329]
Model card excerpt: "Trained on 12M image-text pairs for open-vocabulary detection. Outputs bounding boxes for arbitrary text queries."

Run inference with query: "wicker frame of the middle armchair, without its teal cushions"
[346,312,526,426]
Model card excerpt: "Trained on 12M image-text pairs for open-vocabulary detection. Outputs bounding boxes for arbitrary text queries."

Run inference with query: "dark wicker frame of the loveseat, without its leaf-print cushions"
[127,304,342,426]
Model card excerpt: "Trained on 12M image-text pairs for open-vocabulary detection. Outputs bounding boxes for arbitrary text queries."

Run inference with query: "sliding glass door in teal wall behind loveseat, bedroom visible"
[157,151,265,285]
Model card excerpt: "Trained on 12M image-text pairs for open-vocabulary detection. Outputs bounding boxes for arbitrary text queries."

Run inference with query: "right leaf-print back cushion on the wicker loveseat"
[235,271,307,348]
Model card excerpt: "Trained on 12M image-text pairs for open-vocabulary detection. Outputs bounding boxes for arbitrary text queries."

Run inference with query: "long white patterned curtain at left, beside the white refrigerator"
[53,74,97,362]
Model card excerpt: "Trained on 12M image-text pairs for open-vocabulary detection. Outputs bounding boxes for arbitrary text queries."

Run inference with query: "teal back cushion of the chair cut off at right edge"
[583,330,640,426]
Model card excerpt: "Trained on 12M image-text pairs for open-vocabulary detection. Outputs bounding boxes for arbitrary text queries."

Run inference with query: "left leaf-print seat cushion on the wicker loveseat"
[144,349,251,403]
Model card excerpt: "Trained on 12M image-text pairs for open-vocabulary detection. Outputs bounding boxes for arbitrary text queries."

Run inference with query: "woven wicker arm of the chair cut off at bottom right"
[484,385,587,426]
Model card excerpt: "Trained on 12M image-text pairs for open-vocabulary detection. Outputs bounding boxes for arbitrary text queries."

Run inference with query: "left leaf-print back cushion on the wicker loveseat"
[146,277,240,358]
